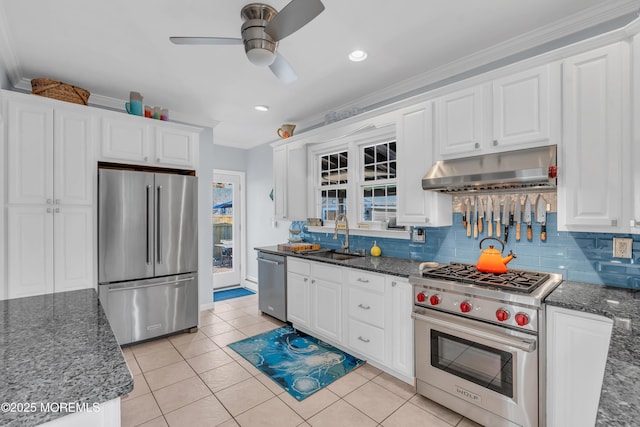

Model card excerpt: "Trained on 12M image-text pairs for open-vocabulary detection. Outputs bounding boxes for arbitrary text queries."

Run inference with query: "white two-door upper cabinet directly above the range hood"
[434,63,560,160]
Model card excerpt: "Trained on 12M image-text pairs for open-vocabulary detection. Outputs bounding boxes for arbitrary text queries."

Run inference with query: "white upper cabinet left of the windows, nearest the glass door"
[273,144,308,221]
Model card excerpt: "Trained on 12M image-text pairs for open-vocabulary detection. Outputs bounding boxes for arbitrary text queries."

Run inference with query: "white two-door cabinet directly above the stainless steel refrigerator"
[100,113,199,169]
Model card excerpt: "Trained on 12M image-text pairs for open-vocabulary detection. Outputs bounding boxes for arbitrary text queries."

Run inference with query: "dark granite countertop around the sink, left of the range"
[255,246,422,277]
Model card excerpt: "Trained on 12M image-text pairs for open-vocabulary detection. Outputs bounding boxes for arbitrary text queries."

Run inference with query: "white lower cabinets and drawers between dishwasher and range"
[287,257,414,385]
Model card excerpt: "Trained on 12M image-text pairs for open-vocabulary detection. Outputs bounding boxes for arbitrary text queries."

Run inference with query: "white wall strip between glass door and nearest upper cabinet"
[246,144,290,281]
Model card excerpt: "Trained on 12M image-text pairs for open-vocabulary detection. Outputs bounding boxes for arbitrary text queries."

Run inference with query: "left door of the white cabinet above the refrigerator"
[100,116,150,164]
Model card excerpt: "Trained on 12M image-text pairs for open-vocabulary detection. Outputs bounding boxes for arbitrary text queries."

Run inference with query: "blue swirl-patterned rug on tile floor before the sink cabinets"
[229,326,365,400]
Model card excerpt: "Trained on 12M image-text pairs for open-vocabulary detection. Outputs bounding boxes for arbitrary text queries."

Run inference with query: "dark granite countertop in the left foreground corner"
[0,289,133,427]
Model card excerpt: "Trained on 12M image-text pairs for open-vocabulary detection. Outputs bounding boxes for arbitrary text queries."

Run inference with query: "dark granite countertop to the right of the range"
[545,281,640,427]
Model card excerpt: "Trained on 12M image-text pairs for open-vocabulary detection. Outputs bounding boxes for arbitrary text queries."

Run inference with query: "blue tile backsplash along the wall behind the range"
[296,212,640,289]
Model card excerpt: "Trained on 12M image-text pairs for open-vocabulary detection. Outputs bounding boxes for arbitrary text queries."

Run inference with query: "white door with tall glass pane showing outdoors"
[211,170,244,289]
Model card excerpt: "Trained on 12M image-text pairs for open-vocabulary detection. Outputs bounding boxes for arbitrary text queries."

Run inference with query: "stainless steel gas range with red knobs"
[409,263,562,427]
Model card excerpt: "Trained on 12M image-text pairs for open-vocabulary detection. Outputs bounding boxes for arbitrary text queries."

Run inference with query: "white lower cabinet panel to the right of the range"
[547,306,613,427]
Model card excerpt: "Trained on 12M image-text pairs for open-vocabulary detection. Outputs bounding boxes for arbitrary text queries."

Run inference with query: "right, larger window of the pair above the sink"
[360,141,397,221]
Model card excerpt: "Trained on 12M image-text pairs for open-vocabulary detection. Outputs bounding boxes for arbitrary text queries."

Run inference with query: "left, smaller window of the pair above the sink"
[319,150,349,221]
